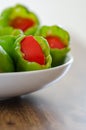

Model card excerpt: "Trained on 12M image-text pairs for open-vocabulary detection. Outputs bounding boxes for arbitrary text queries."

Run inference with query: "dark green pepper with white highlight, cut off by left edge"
[0,45,14,73]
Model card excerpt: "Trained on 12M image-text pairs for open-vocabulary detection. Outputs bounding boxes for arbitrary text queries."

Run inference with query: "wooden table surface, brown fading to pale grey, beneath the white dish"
[0,34,86,130]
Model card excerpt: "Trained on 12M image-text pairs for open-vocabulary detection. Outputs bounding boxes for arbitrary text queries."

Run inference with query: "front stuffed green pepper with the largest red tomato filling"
[13,35,52,71]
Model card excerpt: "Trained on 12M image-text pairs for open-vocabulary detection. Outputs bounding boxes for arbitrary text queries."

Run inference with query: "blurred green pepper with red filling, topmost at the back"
[0,4,39,35]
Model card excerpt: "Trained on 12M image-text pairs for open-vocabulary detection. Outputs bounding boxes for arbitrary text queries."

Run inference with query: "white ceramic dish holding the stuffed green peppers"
[0,55,73,99]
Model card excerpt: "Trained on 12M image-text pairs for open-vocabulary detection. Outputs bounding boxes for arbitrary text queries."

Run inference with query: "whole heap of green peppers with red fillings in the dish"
[0,4,70,72]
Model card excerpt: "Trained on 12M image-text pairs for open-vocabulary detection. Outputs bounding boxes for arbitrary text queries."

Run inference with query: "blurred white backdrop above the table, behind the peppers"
[0,0,86,47]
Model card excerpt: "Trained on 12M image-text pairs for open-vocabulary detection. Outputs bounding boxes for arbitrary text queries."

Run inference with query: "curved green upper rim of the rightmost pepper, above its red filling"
[35,25,70,46]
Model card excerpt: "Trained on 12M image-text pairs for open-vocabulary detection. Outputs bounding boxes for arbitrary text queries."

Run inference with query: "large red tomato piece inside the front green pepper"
[21,36,45,65]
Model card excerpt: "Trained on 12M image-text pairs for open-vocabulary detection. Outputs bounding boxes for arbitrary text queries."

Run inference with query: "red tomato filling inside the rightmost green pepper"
[46,36,65,49]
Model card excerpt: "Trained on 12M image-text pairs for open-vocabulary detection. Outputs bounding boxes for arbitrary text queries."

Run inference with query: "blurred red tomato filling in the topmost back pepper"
[9,17,35,31]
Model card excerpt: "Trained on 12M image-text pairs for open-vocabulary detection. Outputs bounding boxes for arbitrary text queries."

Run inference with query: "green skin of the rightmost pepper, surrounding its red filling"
[35,25,70,67]
